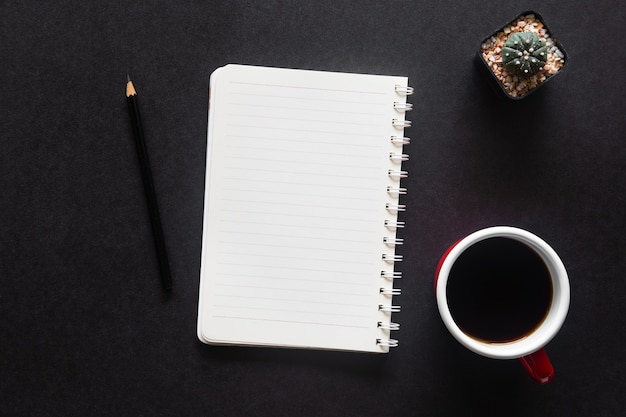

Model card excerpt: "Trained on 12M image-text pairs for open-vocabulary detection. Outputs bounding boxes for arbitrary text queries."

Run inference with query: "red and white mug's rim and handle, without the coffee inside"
[435,226,570,384]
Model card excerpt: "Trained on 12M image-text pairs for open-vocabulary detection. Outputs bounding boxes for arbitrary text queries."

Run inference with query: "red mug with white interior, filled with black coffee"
[435,226,570,384]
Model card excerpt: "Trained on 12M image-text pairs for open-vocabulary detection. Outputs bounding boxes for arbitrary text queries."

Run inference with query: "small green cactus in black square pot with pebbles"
[477,11,567,100]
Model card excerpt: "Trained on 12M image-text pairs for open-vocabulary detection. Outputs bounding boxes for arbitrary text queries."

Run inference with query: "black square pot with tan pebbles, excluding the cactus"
[476,10,568,100]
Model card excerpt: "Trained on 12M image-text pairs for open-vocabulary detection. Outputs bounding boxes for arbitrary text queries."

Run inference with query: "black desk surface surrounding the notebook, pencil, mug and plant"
[0,0,626,416]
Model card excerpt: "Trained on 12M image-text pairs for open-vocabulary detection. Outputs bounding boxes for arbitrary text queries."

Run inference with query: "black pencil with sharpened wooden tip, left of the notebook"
[126,76,172,291]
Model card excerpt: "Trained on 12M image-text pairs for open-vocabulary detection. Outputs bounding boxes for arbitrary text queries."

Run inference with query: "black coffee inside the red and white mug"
[447,237,552,343]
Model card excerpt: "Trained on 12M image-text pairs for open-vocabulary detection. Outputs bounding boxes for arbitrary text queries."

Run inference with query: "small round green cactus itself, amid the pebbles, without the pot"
[502,32,548,75]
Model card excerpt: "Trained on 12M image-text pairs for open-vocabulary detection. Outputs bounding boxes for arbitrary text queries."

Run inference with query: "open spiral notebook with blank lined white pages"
[197,65,413,352]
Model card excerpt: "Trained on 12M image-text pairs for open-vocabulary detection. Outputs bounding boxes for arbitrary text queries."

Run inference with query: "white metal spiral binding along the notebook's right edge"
[376,84,413,348]
